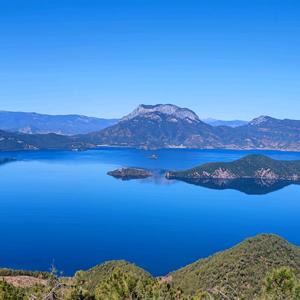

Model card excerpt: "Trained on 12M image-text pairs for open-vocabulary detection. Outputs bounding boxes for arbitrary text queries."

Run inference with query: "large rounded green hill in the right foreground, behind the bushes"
[170,235,300,299]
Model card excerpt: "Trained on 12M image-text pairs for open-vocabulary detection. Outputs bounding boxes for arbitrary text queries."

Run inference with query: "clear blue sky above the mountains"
[0,0,300,119]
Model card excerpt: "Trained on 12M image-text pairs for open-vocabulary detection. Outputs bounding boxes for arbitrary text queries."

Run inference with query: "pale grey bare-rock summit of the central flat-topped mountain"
[122,104,200,122]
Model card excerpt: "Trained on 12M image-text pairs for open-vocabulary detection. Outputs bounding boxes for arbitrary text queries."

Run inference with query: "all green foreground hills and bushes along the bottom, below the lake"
[0,235,300,300]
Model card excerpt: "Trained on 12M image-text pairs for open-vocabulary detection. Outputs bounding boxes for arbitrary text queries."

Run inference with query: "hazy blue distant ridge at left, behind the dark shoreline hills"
[0,111,118,135]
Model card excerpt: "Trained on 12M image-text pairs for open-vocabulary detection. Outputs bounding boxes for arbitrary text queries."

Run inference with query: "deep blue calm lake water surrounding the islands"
[0,149,300,275]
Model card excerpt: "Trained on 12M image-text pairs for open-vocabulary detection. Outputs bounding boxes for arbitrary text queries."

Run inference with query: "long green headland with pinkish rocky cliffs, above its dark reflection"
[166,155,300,182]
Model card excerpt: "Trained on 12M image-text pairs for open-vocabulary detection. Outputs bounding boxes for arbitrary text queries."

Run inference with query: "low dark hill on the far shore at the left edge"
[0,130,88,151]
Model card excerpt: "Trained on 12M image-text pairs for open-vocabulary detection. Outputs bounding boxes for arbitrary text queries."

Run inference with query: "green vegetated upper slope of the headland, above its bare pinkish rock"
[171,155,300,178]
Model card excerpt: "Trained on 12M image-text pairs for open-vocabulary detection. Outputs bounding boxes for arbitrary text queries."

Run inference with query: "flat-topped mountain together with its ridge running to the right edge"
[81,104,300,151]
